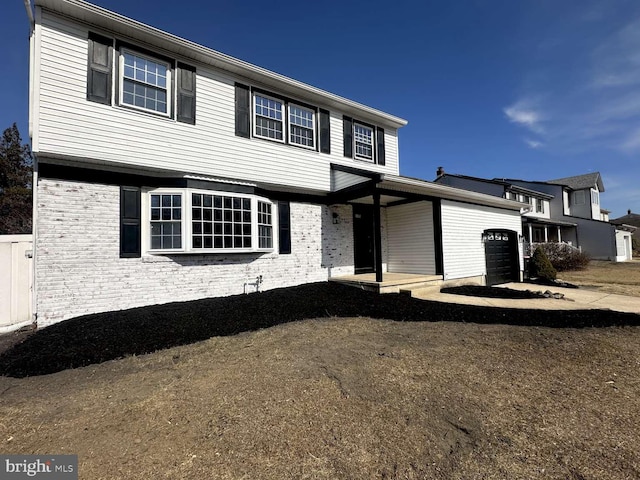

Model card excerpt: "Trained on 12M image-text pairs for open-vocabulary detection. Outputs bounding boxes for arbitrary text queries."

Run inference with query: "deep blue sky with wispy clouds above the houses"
[0,0,640,217]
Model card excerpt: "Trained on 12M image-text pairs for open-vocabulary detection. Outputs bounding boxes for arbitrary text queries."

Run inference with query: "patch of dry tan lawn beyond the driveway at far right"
[558,259,640,297]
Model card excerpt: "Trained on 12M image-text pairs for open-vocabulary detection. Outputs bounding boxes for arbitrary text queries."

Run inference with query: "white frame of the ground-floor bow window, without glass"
[141,188,278,255]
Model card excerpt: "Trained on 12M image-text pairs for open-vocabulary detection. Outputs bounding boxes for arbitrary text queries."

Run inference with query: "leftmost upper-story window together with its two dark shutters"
[87,33,196,124]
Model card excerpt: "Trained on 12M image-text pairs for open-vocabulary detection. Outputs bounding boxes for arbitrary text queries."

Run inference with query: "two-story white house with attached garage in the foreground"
[23,0,524,326]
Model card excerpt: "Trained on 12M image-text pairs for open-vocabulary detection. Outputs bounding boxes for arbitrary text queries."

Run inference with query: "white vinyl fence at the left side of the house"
[0,235,33,333]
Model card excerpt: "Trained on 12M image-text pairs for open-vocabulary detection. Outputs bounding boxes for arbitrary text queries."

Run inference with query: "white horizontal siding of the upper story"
[33,11,398,191]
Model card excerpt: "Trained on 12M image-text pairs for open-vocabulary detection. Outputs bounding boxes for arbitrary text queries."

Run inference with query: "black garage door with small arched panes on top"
[484,230,518,285]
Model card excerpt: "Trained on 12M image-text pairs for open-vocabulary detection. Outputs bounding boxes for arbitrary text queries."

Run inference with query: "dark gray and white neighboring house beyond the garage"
[436,169,627,261]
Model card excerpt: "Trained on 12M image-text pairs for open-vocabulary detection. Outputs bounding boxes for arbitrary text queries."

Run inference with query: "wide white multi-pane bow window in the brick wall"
[147,189,274,253]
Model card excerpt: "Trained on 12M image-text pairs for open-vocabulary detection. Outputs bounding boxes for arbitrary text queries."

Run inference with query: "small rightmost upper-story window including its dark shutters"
[342,116,386,165]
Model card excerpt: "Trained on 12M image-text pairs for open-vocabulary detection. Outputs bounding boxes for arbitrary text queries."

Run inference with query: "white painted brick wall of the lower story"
[35,178,364,327]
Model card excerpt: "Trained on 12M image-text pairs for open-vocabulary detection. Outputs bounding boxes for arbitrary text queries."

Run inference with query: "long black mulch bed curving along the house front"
[0,282,640,377]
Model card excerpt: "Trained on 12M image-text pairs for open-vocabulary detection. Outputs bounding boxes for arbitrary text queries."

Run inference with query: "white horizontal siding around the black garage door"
[442,200,522,280]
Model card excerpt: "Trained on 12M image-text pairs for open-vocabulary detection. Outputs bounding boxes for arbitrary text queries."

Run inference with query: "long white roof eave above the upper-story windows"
[35,0,407,128]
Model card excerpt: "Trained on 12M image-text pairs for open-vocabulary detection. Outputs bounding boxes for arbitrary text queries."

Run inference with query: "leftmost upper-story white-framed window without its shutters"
[120,48,171,116]
